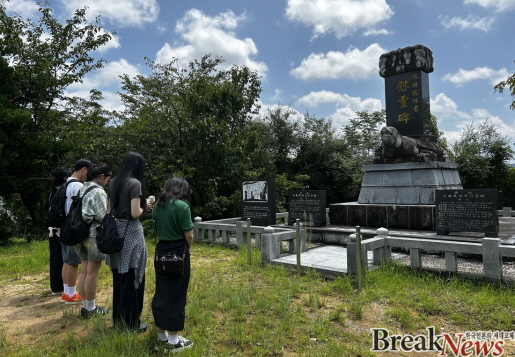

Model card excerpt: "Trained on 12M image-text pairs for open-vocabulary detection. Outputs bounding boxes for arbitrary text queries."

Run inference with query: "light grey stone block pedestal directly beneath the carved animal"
[358,161,463,205]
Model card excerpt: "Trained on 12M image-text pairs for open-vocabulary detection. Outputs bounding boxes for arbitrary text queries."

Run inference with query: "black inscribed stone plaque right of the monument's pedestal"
[435,189,499,237]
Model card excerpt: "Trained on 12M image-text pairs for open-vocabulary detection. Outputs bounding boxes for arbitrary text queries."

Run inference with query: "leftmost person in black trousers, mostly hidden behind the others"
[48,167,70,295]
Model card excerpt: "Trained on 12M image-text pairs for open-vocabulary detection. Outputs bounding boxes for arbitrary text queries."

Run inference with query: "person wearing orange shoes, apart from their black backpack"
[61,159,91,305]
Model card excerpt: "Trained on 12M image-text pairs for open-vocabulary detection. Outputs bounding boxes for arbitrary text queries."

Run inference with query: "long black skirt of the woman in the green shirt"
[152,240,190,331]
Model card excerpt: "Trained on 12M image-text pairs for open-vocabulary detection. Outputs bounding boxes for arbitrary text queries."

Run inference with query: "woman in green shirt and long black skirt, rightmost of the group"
[152,177,193,352]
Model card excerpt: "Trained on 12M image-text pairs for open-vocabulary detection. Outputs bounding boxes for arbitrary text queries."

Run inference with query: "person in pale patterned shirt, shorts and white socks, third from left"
[75,165,112,318]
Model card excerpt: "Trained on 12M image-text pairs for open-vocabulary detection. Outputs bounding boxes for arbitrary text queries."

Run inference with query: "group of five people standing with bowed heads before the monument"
[49,152,193,351]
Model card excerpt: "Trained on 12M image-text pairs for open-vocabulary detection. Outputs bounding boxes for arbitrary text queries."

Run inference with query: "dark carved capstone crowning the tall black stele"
[379,45,433,78]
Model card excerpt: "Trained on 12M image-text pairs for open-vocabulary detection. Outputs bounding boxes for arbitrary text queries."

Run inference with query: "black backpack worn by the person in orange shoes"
[59,186,98,246]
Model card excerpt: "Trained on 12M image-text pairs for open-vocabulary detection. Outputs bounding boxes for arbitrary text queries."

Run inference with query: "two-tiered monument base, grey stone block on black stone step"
[329,161,462,230]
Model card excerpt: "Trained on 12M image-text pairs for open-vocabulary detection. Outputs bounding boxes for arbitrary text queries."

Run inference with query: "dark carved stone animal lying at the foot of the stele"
[374,126,447,164]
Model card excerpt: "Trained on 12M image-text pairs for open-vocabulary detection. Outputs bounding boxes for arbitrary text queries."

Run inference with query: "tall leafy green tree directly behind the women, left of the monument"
[117,55,261,218]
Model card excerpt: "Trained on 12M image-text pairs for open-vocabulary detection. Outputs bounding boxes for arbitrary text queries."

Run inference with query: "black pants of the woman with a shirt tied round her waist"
[112,269,145,330]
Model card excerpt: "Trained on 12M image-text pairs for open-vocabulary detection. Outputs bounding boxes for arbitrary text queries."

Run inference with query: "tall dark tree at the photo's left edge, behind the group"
[0,2,111,226]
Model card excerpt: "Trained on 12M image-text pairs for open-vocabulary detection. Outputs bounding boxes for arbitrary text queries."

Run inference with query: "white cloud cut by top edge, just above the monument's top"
[286,0,394,38]
